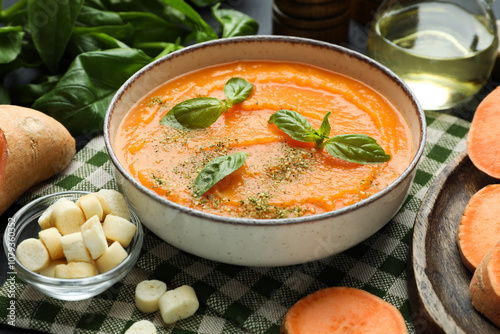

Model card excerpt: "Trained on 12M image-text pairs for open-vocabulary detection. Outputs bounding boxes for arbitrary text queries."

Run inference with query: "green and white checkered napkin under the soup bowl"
[0,113,469,334]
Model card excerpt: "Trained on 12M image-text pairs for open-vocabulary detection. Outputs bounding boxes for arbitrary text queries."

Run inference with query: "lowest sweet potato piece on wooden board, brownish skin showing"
[469,242,500,327]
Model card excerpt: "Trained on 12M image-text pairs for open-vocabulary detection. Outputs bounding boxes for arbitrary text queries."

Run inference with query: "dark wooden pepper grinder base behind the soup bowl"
[273,0,351,44]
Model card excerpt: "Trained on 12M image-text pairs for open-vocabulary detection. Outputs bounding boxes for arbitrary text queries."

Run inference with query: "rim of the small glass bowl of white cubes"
[3,190,144,288]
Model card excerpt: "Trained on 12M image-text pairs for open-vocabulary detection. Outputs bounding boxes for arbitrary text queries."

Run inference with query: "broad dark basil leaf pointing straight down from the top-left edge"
[28,0,83,72]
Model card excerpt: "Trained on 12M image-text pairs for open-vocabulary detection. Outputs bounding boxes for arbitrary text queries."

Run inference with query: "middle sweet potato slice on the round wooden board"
[458,184,500,272]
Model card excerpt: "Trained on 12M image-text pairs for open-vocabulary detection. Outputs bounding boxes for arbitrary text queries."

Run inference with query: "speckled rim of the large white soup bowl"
[103,35,427,226]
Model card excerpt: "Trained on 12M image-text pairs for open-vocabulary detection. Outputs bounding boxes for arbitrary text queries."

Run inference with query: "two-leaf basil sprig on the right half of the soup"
[268,109,391,164]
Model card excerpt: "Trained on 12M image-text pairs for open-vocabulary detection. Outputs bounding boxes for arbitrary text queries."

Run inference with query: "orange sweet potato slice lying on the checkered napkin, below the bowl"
[280,287,408,334]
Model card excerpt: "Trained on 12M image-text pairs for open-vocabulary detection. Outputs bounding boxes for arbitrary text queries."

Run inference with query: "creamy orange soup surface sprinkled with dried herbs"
[115,61,413,219]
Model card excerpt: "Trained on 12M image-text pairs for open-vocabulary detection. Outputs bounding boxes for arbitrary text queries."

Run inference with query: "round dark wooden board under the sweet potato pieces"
[408,152,500,334]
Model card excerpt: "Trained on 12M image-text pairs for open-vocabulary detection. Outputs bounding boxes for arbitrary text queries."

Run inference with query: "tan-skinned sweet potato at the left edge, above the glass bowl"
[0,105,76,215]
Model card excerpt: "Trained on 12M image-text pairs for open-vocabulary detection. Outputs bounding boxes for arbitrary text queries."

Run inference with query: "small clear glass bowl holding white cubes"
[3,191,144,301]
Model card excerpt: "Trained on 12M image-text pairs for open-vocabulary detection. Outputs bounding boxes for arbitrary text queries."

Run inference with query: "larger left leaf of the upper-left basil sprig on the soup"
[172,97,228,129]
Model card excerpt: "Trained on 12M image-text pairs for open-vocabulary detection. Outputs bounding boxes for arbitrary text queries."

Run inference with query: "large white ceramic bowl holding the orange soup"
[104,36,426,266]
